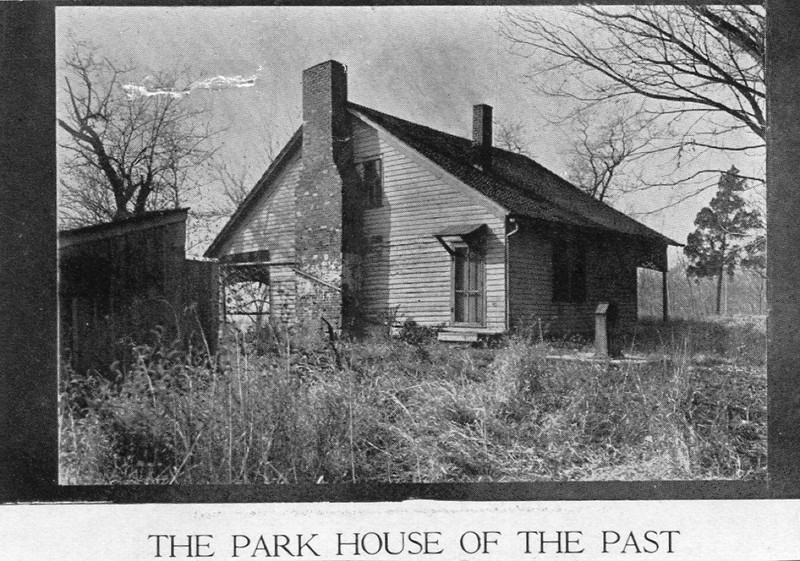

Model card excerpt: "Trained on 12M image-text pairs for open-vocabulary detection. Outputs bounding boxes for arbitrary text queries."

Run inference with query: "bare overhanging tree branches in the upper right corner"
[501,3,766,200]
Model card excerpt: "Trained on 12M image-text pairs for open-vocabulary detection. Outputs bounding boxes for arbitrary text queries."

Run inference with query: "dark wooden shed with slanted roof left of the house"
[58,209,219,372]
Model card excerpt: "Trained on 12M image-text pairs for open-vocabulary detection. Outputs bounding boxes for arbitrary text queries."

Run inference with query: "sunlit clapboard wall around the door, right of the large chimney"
[353,119,505,331]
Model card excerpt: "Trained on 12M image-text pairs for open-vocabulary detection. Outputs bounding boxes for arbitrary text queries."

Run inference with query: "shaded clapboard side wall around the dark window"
[509,226,637,333]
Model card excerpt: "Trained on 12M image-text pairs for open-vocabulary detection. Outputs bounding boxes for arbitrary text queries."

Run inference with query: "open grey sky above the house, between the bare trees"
[56,6,759,255]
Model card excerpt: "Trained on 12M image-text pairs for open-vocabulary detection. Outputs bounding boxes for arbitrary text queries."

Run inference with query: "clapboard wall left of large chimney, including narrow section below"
[222,155,302,321]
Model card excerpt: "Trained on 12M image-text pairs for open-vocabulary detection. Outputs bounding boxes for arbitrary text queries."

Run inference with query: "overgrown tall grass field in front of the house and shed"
[61,310,766,484]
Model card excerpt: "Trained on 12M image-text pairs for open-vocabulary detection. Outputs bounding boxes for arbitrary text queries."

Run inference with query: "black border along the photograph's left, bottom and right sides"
[0,0,800,503]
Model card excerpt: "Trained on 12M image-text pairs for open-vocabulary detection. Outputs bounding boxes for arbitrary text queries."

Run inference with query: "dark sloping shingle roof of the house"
[349,103,680,245]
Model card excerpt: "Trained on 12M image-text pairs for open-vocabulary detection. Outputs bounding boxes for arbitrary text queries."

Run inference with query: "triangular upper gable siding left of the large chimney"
[223,151,301,261]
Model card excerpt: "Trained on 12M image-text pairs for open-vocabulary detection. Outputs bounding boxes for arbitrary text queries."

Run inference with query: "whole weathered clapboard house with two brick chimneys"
[206,61,678,340]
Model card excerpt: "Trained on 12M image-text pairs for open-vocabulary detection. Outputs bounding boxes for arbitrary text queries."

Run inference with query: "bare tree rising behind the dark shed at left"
[58,42,214,225]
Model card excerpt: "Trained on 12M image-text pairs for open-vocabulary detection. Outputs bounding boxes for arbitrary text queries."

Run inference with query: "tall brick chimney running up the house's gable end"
[295,60,352,330]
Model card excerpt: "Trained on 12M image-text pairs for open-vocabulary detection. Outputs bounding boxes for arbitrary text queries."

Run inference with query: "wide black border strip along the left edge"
[0,2,58,498]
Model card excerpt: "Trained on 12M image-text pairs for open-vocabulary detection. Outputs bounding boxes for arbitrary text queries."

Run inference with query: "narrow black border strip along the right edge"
[767,0,800,498]
